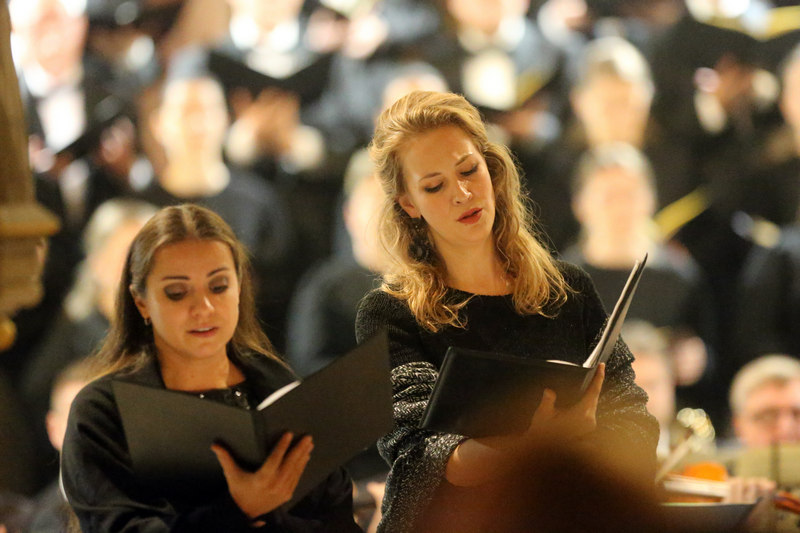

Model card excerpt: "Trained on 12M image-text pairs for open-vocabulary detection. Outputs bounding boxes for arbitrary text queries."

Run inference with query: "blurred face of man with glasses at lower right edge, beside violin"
[733,379,800,447]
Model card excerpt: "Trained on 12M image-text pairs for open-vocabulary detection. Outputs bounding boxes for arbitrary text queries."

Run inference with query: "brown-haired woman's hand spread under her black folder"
[211,433,314,518]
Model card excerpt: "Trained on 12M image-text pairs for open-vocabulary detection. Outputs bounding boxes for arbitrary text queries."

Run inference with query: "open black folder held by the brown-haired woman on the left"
[113,332,392,505]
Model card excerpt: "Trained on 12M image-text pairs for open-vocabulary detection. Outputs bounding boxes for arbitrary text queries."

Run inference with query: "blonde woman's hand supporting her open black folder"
[524,363,606,444]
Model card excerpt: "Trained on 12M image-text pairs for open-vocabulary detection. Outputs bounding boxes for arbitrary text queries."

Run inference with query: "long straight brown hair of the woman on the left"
[88,204,278,377]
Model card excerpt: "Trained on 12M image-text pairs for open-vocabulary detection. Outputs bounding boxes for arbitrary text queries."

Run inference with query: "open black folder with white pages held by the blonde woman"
[420,255,647,437]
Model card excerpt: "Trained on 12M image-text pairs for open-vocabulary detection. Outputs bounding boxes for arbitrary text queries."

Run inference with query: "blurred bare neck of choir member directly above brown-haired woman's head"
[159,157,230,198]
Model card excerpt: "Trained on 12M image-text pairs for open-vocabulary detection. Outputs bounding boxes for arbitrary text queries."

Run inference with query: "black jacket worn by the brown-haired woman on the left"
[61,355,361,533]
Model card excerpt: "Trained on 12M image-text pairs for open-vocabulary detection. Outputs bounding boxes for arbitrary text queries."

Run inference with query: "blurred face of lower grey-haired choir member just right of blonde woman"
[573,167,655,239]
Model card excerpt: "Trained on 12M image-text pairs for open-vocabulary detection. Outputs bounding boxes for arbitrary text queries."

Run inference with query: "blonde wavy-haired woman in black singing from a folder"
[356,91,658,533]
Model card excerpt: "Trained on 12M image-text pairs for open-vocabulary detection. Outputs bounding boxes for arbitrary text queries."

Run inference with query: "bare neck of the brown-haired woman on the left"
[158,354,244,391]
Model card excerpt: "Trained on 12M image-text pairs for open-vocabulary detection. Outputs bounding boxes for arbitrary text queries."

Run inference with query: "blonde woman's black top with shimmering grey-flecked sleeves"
[356,262,658,533]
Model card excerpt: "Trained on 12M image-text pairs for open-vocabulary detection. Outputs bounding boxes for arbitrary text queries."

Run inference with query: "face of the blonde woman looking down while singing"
[398,126,495,253]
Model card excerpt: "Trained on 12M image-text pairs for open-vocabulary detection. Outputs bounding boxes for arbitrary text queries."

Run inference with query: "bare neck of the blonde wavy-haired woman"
[438,239,509,295]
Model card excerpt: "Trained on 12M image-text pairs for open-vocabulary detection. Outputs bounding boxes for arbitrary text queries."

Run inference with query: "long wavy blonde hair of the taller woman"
[369,91,570,332]
